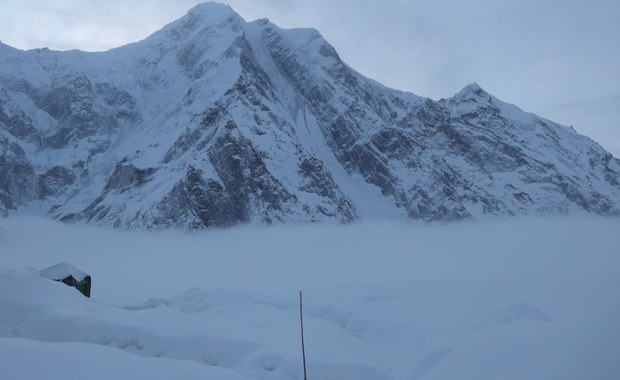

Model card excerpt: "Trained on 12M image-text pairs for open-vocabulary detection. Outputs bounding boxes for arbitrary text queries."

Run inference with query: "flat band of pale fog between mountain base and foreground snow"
[0,217,620,302]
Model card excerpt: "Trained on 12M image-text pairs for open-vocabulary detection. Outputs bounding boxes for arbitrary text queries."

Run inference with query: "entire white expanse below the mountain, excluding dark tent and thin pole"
[0,218,620,380]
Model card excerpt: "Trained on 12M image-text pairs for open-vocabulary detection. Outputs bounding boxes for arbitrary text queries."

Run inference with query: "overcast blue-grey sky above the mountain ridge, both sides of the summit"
[0,0,620,157]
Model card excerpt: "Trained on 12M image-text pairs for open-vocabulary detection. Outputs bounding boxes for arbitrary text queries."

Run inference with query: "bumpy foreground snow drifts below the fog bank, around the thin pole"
[0,269,620,380]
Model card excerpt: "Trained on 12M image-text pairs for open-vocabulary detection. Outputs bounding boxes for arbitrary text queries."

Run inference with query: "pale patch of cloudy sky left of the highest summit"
[0,0,196,51]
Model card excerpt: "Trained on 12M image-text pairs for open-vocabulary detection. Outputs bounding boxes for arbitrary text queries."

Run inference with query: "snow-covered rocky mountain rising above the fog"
[0,3,620,229]
